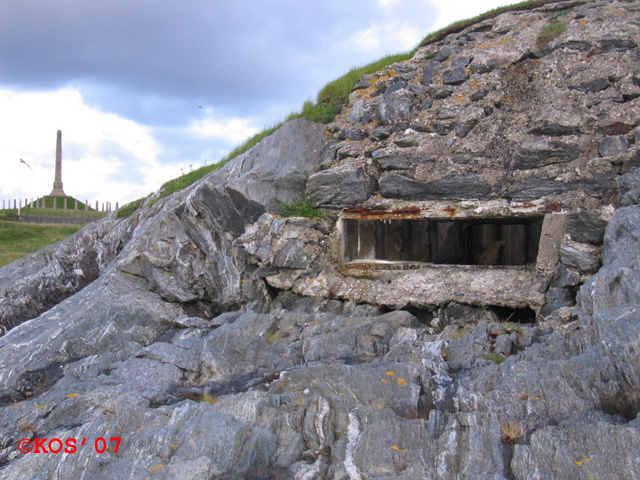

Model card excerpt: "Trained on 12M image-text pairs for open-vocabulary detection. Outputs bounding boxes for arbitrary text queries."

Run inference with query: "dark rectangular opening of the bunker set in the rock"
[342,215,544,267]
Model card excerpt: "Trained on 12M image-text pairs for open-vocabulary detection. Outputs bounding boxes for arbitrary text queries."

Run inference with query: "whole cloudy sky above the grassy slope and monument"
[0,0,513,208]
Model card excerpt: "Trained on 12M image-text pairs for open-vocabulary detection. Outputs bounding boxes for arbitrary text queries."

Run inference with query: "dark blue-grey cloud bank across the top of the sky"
[0,0,433,123]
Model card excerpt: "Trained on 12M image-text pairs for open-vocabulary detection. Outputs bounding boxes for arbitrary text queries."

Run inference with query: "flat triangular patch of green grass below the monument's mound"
[0,220,82,267]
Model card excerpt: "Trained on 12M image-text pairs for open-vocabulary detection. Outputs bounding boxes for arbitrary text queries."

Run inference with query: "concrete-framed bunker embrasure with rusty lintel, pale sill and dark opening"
[337,201,568,310]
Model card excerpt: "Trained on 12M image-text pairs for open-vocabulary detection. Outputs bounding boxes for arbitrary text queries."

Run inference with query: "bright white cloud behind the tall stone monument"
[0,88,175,204]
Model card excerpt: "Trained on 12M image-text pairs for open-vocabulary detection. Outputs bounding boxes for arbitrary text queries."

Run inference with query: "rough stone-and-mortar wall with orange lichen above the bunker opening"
[307,2,640,209]
